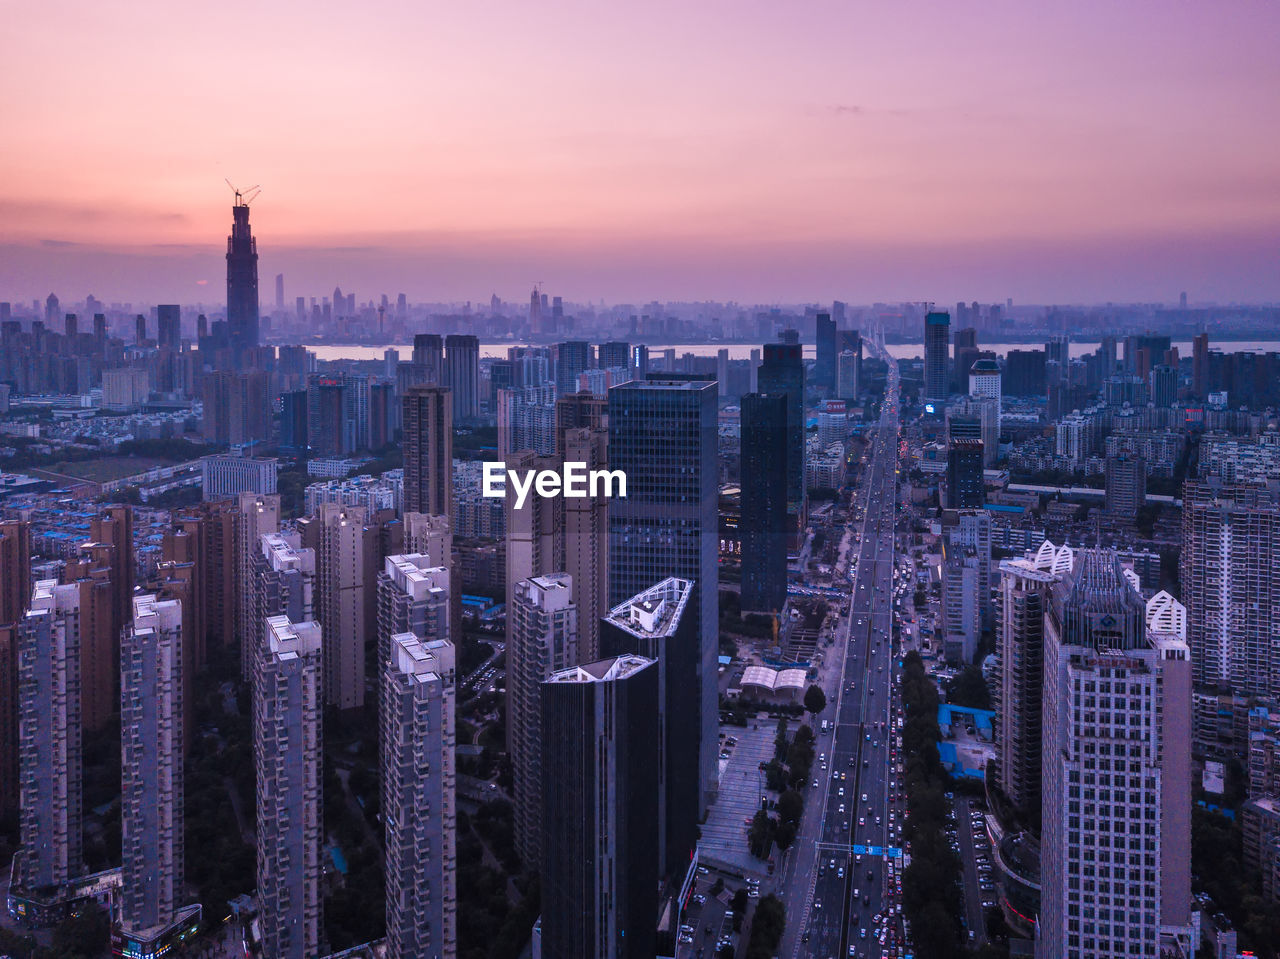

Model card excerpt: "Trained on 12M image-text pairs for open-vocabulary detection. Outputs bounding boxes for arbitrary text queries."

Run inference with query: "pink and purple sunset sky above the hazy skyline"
[0,0,1280,302]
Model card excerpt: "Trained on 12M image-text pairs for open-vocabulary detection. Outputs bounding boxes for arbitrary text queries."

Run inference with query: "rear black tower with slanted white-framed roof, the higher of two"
[600,576,699,877]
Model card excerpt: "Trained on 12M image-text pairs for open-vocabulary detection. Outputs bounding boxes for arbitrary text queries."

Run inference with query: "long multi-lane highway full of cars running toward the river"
[782,340,901,959]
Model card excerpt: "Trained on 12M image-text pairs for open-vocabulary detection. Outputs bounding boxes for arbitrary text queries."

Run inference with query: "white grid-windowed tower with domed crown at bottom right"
[1036,551,1197,959]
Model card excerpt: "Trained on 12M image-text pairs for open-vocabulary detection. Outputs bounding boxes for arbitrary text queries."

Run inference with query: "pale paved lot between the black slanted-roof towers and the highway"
[699,717,777,874]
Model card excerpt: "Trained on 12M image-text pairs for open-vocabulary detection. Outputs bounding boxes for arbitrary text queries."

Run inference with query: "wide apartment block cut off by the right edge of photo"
[1179,480,1280,698]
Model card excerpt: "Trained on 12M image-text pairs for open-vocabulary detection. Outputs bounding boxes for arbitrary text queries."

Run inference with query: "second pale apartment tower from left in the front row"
[120,594,186,940]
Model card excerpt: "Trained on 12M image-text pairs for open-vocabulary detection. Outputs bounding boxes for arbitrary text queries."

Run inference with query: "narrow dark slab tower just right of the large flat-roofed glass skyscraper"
[740,393,788,613]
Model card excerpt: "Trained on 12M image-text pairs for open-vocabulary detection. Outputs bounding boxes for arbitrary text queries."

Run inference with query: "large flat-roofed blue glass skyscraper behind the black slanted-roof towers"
[609,380,719,803]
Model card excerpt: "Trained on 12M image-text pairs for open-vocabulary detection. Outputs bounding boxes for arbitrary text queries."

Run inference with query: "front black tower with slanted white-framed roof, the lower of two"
[541,655,660,959]
